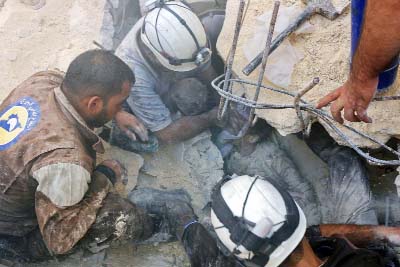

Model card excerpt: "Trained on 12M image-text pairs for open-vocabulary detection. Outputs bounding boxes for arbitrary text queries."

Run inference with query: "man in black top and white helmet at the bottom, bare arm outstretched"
[211,175,400,267]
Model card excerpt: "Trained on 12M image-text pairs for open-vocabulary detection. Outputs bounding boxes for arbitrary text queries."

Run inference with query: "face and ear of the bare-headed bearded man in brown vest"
[86,81,131,128]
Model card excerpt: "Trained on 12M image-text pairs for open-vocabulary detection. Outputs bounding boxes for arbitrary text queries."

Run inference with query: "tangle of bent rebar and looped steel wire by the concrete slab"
[216,2,400,165]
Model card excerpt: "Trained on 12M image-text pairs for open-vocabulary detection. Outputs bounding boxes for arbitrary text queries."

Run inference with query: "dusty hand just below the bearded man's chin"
[115,111,149,142]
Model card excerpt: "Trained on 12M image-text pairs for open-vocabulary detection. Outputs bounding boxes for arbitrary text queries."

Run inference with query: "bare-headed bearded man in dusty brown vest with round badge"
[0,50,231,266]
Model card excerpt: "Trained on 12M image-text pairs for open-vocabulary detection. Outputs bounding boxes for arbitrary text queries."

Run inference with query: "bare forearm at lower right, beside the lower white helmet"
[319,224,400,246]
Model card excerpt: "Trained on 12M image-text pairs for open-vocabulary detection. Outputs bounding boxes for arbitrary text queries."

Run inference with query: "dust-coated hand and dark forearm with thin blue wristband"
[129,188,235,267]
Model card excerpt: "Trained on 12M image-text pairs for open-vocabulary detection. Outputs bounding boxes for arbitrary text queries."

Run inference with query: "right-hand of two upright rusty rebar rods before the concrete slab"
[249,1,281,120]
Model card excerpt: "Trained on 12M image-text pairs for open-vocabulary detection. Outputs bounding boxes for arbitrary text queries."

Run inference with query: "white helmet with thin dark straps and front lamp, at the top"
[140,0,211,72]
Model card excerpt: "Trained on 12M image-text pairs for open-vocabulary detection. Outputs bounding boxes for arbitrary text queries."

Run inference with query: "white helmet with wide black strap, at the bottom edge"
[211,175,306,267]
